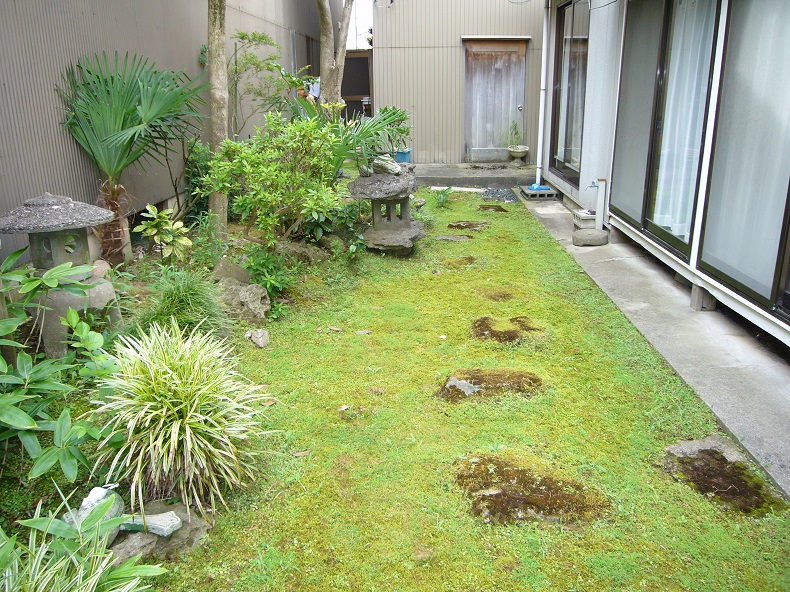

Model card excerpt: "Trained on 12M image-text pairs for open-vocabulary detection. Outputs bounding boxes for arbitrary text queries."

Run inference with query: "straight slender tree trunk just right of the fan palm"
[207,0,228,236]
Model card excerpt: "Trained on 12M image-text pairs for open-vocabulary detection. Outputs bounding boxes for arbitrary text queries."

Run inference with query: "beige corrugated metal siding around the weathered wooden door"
[373,0,543,163]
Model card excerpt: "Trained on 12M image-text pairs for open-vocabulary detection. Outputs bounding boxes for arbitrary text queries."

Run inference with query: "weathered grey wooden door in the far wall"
[464,40,527,162]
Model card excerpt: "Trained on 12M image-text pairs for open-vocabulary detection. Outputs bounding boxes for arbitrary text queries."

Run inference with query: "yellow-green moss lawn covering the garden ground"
[156,190,790,591]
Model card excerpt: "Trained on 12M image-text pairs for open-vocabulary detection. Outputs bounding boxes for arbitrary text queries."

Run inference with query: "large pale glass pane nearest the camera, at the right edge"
[700,0,790,304]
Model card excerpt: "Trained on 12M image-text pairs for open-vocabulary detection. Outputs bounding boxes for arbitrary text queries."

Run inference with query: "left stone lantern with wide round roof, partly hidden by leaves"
[0,193,121,358]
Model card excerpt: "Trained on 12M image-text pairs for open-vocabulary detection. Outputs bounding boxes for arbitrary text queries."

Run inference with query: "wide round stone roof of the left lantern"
[0,193,115,234]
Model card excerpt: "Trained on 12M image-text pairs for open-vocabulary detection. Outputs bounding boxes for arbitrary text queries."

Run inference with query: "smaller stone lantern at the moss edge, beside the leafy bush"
[348,161,425,255]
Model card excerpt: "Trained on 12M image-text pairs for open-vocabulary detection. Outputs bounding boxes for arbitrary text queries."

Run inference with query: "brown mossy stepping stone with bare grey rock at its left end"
[436,368,543,403]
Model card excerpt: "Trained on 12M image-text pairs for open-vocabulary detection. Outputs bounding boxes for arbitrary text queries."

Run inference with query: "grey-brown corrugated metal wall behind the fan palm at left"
[0,0,324,254]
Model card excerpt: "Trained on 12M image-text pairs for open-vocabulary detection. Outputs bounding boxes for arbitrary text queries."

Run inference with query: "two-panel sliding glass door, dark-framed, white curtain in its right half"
[611,0,718,258]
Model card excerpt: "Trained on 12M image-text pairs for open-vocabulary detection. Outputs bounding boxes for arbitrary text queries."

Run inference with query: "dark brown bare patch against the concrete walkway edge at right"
[664,448,788,516]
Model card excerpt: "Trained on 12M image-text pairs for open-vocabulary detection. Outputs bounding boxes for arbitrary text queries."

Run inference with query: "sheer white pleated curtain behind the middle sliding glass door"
[650,0,716,243]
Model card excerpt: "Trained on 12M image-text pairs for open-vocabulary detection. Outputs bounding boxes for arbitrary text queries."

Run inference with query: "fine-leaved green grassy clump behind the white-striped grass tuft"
[136,267,230,335]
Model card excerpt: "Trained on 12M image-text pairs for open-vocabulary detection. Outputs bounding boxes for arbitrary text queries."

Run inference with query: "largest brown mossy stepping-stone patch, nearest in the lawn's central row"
[454,455,608,524]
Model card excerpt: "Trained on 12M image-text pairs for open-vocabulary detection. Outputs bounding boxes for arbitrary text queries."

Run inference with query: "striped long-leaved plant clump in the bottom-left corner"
[0,492,167,592]
